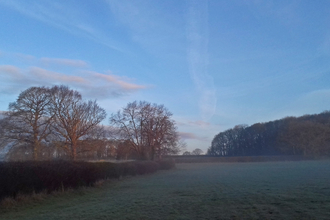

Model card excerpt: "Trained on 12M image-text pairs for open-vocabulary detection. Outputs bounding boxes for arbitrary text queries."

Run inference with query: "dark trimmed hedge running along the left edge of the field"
[0,160,175,199]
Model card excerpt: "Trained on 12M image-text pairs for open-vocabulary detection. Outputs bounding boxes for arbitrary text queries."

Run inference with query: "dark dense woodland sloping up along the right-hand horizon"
[207,111,330,156]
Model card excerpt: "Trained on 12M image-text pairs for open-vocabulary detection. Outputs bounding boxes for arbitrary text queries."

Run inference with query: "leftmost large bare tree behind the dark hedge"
[1,87,53,160]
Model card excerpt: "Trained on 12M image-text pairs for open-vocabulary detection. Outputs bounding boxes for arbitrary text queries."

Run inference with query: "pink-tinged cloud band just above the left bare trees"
[0,65,147,99]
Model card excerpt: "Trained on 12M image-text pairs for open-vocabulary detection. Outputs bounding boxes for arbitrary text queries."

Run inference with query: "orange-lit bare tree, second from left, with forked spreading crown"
[51,86,106,160]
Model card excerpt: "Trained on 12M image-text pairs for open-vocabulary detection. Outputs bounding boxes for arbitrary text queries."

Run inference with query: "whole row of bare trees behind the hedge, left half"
[0,85,182,160]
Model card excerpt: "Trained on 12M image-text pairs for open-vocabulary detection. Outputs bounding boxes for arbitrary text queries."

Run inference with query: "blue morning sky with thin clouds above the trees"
[0,0,330,152]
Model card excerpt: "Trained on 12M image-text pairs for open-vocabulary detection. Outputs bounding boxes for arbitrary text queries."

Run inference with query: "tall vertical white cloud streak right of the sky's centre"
[186,0,217,121]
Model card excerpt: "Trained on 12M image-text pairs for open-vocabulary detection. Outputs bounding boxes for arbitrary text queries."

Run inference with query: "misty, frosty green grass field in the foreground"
[0,161,330,220]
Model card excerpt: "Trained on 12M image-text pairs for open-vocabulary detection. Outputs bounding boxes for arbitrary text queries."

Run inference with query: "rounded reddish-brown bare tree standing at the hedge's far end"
[110,101,178,160]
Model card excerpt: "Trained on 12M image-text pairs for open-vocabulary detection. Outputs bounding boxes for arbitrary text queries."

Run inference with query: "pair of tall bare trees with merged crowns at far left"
[0,86,106,160]
